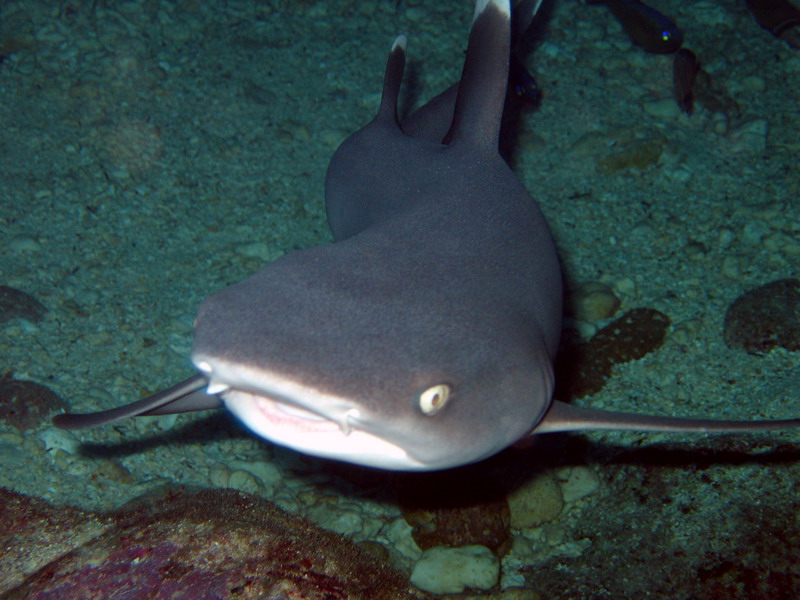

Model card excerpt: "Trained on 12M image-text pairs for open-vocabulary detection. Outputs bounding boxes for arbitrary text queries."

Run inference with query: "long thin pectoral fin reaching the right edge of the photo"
[531,400,800,434]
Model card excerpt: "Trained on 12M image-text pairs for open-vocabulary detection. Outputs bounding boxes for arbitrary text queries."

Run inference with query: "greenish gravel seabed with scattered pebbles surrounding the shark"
[0,0,800,600]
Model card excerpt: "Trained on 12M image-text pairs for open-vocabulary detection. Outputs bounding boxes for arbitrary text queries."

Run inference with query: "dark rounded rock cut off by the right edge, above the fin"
[723,279,800,354]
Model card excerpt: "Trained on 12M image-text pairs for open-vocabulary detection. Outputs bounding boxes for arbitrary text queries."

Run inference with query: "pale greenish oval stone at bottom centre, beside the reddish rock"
[411,546,500,594]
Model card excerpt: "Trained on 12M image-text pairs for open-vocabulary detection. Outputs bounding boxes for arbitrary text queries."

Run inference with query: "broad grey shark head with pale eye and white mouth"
[192,240,552,470]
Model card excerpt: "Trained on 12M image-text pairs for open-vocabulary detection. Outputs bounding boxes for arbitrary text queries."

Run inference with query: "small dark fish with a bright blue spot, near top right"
[587,0,683,54]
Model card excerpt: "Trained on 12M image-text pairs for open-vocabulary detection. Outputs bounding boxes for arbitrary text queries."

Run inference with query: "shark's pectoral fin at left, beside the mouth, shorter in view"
[53,375,222,429]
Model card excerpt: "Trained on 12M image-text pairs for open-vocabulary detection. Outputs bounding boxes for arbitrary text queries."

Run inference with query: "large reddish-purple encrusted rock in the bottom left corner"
[0,488,425,600]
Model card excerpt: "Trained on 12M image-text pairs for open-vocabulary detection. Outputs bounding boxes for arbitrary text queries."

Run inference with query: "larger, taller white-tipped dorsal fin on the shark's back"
[444,0,511,151]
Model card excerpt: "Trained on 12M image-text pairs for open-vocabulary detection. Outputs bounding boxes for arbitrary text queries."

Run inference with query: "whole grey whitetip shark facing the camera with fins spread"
[54,0,800,471]
